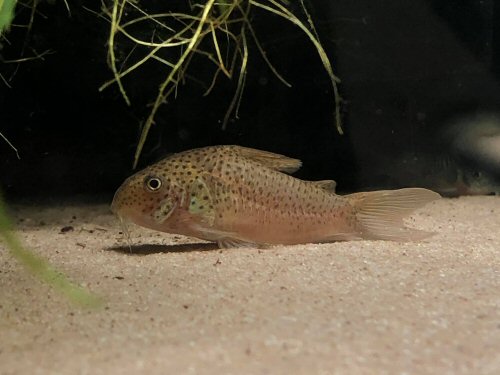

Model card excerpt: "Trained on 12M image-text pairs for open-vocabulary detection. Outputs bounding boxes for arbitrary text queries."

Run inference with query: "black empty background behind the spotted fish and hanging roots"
[0,0,500,200]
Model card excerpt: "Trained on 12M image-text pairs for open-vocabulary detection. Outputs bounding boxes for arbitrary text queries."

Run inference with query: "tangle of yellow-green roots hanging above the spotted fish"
[100,0,342,167]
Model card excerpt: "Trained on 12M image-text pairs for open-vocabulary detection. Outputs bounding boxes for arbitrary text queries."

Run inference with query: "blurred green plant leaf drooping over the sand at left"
[0,196,101,307]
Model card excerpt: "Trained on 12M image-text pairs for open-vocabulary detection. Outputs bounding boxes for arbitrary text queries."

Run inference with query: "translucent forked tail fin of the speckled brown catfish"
[347,188,441,241]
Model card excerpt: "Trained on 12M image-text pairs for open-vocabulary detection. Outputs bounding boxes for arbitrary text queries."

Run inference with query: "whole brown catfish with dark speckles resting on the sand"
[111,145,440,248]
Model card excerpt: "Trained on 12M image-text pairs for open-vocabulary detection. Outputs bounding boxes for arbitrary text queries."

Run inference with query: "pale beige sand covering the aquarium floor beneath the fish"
[0,197,500,374]
